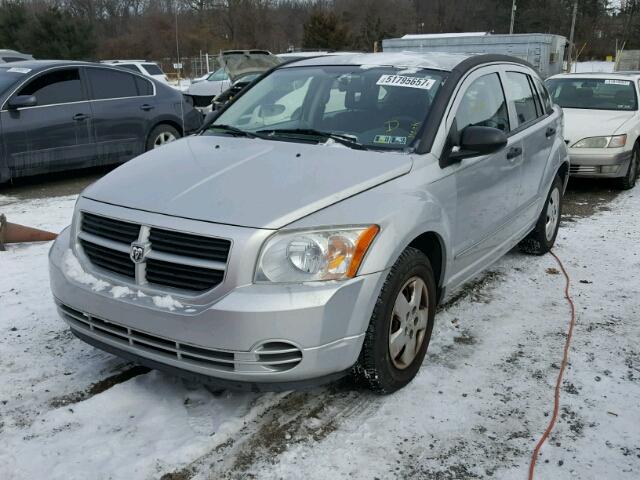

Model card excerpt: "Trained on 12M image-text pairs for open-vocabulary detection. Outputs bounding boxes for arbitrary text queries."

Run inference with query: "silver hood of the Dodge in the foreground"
[82,135,412,229]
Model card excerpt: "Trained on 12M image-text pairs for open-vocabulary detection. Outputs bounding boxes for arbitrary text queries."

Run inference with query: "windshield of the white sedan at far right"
[546,78,638,110]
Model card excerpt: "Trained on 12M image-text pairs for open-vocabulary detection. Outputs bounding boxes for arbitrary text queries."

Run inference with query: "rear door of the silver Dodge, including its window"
[503,66,558,228]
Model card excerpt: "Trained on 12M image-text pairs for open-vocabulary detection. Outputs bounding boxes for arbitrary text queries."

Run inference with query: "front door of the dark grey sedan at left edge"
[0,67,95,176]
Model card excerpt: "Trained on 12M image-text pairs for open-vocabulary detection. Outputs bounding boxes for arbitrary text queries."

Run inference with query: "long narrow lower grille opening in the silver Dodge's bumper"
[58,304,302,373]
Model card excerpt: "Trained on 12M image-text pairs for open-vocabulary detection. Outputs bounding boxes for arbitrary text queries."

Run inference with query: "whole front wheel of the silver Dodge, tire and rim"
[354,247,436,394]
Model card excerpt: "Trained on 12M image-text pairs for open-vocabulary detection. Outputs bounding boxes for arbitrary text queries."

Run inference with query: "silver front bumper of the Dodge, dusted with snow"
[49,230,386,388]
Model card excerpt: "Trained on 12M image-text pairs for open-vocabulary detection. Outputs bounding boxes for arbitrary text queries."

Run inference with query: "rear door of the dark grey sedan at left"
[85,67,155,162]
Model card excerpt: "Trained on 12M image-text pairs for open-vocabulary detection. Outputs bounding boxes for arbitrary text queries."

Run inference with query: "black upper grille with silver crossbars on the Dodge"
[78,212,231,293]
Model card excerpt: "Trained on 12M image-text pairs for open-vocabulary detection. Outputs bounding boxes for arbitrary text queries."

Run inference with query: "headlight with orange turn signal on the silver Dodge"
[255,225,380,283]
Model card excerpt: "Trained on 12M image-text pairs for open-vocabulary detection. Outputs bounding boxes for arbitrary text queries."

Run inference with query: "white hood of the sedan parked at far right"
[562,108,636,145]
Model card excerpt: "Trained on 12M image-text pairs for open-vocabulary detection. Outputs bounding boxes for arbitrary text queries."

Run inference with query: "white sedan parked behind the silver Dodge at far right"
[546,72,640,189]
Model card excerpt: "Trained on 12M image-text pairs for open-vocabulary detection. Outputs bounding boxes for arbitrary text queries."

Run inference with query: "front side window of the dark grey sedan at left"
[17,68,86,106]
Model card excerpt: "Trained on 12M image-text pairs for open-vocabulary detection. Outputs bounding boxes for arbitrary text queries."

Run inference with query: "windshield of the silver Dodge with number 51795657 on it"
[212,66,446,150]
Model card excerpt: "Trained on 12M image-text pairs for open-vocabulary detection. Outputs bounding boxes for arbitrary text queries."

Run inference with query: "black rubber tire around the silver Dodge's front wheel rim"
[353,247,436,394]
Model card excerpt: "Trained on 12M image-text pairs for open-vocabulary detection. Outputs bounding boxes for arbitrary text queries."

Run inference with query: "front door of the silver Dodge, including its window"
[450,67,523,283]
